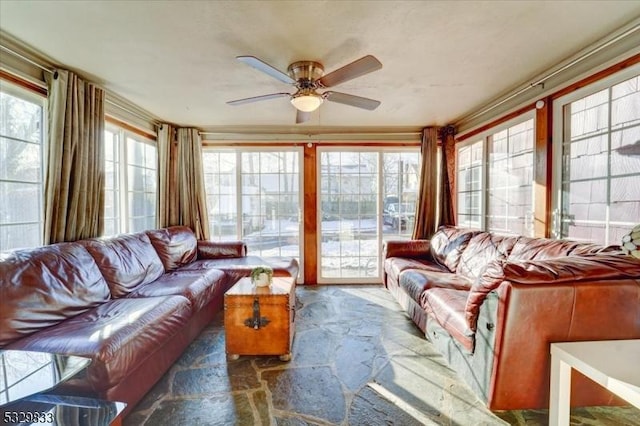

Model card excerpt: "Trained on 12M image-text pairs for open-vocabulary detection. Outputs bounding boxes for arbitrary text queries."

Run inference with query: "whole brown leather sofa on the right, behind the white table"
[383,227,640,410]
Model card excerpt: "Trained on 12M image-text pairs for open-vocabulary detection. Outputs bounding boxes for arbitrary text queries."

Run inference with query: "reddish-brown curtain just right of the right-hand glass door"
[412,127,438,239]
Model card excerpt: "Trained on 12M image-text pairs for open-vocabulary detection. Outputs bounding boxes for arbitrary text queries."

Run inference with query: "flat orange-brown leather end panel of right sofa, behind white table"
[476,256,640,410]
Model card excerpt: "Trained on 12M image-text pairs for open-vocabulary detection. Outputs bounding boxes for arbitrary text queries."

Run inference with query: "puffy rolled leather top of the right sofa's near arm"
[465,254,640,330]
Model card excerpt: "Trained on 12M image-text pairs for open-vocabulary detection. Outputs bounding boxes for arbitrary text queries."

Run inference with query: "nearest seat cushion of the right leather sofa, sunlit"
[420,288,474,353]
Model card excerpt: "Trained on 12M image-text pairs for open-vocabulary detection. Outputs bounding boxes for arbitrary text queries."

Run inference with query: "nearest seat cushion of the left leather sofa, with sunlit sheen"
[7,296,192,392]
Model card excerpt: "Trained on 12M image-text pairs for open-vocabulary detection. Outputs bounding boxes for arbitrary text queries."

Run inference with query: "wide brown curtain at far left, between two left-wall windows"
[44,70,105,244]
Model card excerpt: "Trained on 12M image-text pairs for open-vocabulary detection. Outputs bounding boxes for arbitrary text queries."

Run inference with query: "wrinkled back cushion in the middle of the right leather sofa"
[456,232,518,281]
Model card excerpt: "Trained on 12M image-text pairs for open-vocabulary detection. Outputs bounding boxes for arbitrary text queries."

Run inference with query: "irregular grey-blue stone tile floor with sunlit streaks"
[124,286,640,426]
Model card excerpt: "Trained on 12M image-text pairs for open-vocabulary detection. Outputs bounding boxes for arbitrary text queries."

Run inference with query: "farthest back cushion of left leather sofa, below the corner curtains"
[147,226,198,272]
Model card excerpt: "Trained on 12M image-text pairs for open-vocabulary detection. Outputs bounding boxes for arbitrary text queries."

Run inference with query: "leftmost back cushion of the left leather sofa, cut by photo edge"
[0,243,110,348]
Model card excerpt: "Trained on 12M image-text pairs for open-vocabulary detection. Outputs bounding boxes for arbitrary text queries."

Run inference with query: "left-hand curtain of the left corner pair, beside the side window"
[157,123,180,228]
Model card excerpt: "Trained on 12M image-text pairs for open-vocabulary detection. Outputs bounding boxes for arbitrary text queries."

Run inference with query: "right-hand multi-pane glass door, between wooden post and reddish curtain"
[318,148,420,282]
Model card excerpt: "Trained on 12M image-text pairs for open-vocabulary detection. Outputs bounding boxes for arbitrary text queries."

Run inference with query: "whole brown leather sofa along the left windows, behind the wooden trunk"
[0,226,298,412]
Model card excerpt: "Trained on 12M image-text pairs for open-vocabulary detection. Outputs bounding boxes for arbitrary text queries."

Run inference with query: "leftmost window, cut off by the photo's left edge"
[0,81,44,251]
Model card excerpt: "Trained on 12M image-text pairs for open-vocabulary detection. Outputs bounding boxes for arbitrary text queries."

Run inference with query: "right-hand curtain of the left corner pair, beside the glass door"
[177,128,209,240]
